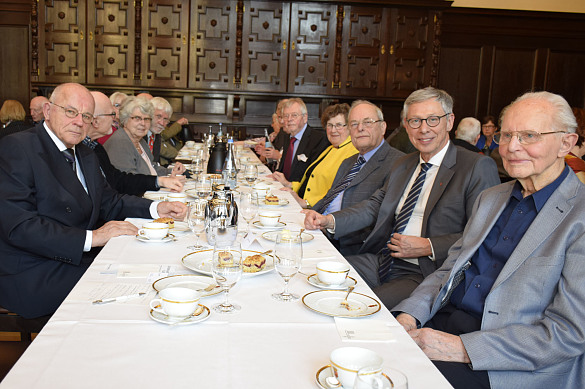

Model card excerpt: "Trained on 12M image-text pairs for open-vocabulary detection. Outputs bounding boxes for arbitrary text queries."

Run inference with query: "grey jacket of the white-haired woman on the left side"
[104,128,169,176]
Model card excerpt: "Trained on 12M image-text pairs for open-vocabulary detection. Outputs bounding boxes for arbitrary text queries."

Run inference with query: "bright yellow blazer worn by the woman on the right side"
[292,136,358,205]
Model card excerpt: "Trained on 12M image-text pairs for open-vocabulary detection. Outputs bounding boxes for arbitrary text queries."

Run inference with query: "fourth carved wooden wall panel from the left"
[189,0,237,90]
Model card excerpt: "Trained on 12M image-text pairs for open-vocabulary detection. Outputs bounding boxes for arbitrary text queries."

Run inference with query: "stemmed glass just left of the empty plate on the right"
[272,231,303,302]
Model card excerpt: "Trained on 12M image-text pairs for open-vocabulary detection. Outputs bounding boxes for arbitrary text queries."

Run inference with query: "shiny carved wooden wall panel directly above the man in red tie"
[288,2,337,94]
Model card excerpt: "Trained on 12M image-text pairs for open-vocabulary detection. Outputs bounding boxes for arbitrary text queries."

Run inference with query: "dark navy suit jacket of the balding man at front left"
[0,124,151,318]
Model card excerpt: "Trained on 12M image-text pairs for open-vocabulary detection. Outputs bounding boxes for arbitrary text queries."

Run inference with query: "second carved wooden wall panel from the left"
[87,0,136,85]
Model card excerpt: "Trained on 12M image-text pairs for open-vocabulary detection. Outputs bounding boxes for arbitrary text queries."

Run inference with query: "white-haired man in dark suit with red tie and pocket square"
[277,98,329,182]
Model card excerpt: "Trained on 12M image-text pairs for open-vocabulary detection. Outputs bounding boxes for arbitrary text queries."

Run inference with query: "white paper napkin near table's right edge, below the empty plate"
[334,317,396,342]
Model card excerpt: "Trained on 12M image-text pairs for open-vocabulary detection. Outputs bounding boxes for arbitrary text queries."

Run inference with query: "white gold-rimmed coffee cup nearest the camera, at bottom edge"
[329,347,384,389]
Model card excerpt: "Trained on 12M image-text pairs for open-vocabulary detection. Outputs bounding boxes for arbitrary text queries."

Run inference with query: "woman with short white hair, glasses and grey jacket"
[104,97,185,176]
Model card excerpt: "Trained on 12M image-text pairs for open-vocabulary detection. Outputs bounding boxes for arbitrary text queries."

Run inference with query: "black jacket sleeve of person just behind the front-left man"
[93,143,159,196]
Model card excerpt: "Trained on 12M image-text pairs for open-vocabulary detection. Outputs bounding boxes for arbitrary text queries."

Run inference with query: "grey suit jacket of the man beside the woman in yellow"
[313,141,404,255]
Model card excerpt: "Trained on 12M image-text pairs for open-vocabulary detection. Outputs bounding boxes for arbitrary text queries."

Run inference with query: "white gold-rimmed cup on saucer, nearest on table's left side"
[150,287,201,317]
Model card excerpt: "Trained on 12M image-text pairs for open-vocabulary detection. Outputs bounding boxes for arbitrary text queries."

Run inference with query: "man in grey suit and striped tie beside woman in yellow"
[312,100,404,255]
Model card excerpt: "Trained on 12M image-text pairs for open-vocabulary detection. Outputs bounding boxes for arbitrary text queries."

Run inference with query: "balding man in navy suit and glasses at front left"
[0,84,186,318]
